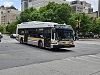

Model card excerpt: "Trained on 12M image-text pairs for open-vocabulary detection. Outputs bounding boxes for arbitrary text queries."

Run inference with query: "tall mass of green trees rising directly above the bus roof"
[17,2,71,24]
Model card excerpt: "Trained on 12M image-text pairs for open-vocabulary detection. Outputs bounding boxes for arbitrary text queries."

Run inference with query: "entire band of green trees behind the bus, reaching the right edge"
[5,2,100,34]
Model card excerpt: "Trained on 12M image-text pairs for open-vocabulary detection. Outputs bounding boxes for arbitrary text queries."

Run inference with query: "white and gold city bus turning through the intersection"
[16,21,75,49]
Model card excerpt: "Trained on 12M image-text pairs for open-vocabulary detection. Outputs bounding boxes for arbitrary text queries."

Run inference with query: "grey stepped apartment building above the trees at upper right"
[70,0,93,13]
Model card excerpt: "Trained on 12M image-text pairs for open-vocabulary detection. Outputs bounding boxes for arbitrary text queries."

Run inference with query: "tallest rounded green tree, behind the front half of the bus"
[39,2,71,24]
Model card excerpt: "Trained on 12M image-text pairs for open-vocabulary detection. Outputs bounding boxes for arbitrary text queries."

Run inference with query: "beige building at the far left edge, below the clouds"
[0,6,20,25]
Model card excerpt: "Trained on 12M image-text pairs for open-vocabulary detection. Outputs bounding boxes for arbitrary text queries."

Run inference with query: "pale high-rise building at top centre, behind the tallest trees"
[21,0,68,11]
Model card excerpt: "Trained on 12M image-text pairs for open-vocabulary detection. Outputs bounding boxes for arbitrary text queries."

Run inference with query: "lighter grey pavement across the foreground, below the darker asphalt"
[0,54,100,75]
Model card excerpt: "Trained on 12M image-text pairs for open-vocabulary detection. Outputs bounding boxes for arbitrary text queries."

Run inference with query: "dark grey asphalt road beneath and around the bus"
[0,35,100,70]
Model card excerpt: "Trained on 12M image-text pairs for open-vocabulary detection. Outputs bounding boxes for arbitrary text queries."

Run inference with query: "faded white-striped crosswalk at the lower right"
[64,53,100,67]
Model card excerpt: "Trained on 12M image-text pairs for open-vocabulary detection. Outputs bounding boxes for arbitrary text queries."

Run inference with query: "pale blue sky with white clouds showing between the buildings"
[0,0,98,11]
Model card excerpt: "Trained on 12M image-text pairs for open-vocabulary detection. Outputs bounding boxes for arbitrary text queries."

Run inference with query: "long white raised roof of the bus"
[17,21,71,28]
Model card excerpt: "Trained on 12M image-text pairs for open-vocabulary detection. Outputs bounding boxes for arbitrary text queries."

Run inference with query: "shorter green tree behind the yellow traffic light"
[71,13,92,33]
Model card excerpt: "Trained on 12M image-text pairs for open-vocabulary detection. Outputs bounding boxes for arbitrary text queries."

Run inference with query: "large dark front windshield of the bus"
[55,29,73,41]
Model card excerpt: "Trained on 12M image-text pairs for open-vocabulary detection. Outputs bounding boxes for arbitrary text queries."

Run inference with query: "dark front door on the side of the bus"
[44,28,51,48]
